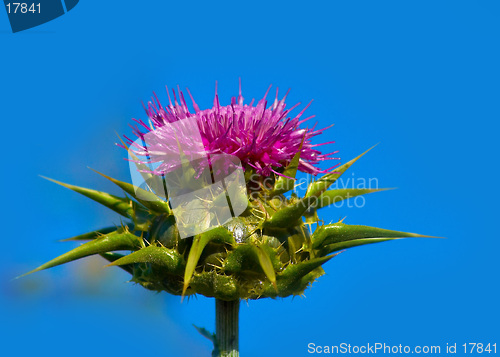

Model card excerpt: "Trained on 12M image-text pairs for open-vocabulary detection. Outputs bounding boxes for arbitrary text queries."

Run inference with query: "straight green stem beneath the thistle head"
[215,299,240,357]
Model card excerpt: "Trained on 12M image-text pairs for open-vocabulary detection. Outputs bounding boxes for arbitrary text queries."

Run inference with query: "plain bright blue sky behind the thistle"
[0,0,500,357]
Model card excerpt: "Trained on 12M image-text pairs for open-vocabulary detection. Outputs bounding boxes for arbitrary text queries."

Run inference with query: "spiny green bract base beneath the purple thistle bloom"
[24,147,430,301]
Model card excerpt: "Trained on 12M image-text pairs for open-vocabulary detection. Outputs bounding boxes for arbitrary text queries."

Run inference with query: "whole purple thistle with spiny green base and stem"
[24,82,430,356]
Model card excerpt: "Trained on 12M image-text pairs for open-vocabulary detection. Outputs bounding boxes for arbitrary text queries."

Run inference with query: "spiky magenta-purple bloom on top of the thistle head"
[125,82,338,176]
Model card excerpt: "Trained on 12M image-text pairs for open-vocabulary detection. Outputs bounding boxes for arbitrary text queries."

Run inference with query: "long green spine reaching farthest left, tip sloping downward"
[19,232,141,278]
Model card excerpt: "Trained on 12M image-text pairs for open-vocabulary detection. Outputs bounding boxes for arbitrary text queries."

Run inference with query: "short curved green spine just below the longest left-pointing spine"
[109,245,186,274]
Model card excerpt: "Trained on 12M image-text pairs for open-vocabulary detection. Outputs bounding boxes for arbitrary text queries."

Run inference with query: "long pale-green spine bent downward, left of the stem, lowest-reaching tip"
[182,227,236,295]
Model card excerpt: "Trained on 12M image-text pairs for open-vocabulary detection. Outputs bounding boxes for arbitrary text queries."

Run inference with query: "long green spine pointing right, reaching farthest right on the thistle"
[312,222,429,249]
